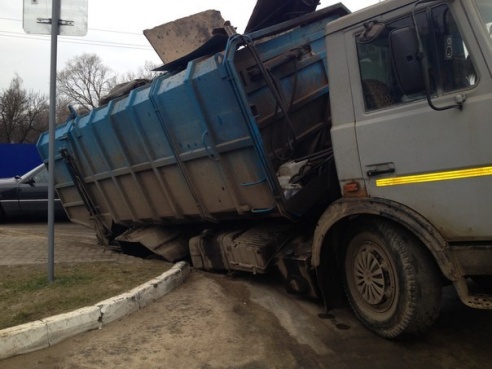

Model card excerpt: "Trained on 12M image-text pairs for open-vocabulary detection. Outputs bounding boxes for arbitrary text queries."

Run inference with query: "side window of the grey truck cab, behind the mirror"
[357,5,476,111]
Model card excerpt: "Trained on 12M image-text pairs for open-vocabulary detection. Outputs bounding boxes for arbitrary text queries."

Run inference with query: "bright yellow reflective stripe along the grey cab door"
[376,166,492,187]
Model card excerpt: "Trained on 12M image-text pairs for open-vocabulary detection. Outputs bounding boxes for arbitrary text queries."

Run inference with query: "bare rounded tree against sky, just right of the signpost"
[56,53,116,110]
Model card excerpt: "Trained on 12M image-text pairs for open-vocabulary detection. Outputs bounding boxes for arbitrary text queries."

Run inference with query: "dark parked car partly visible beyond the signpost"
[0,164,66,218]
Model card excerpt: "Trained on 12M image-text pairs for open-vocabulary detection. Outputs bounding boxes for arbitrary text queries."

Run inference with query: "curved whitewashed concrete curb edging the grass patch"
[0,262,190,360]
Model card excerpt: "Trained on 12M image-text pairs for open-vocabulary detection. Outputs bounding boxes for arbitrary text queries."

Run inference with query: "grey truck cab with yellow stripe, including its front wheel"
[313,0,492,336]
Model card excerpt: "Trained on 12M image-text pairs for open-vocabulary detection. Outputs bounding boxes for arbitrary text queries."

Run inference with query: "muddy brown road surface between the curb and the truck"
[0,221,492,369]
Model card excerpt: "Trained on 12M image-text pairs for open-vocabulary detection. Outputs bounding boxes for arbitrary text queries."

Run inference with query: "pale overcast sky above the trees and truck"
[0,0,378,93]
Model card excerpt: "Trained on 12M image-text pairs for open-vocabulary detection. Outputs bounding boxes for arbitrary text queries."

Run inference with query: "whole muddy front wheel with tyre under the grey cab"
[344,220,442,338]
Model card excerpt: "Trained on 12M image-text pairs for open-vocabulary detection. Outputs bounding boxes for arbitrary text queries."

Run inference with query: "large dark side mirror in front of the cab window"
[389,27,426,95]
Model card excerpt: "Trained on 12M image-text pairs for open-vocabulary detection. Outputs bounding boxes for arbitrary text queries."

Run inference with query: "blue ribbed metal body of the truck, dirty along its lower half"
[37,5,347,233]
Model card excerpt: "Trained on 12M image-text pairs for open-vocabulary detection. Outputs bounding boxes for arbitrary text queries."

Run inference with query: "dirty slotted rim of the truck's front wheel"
[348,241,397,313]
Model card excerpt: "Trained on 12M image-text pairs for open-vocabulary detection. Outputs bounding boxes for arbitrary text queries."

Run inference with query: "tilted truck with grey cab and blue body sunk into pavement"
[37,0,492,338]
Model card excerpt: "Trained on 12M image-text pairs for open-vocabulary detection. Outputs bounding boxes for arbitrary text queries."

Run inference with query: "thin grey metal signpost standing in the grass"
[48,0,60,283]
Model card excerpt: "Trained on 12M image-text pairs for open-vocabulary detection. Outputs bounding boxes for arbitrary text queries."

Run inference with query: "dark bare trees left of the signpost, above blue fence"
[0,75,49,143]
